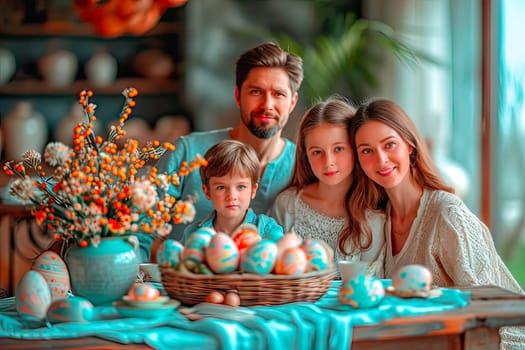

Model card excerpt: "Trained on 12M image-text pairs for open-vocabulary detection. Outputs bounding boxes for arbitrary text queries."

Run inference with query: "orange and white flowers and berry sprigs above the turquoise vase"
[4,88,206,247]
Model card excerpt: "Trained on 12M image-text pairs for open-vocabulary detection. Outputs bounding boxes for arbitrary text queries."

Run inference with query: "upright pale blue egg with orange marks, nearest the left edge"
[15,270,51,320]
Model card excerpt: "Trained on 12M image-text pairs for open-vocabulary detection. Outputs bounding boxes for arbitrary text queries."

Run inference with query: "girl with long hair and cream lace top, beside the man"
[270,97,384,277]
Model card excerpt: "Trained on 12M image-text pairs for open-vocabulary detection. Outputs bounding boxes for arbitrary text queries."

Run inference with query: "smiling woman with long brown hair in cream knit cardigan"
[350,99,525,348]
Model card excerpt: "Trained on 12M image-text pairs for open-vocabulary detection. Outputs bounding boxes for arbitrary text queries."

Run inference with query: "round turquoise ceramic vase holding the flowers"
[65,237,140,305]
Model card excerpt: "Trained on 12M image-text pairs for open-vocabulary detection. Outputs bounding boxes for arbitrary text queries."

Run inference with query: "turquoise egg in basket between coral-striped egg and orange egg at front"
[241,239,277,274]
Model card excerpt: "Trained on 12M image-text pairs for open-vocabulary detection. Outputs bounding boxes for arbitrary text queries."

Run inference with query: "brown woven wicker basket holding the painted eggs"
[160,267,337,306]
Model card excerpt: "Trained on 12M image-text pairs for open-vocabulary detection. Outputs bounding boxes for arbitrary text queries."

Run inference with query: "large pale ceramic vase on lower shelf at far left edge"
[2,101,47,160]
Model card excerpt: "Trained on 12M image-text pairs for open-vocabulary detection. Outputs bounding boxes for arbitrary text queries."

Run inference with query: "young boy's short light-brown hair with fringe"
[199,140,261,186]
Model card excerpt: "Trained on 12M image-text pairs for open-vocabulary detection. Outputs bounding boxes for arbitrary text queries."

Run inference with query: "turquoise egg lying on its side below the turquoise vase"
[47,296,95,323]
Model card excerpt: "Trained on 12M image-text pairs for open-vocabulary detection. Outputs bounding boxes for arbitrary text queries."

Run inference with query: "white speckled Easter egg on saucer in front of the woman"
[392,264,432,292]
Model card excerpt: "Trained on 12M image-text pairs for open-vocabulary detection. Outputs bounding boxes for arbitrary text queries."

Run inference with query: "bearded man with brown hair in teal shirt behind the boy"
[157,43,303,240]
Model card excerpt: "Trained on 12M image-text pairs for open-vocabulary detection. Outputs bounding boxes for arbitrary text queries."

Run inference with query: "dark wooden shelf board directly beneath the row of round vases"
[0,78,182,96]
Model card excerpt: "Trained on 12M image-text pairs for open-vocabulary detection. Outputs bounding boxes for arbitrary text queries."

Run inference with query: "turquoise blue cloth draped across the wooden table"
[0,280,470,350]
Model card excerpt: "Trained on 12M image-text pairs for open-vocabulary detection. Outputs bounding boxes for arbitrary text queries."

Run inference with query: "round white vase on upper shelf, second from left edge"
[38,49,78,87]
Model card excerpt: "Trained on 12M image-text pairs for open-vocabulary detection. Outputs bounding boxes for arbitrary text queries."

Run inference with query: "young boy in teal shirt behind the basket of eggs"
[182,140,283,244]
